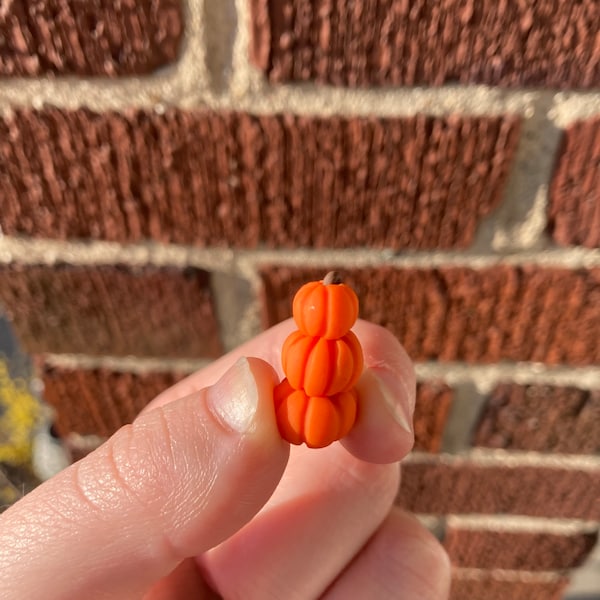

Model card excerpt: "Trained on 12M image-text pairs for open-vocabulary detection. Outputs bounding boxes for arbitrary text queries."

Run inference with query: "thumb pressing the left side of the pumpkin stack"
[0,358,289,599]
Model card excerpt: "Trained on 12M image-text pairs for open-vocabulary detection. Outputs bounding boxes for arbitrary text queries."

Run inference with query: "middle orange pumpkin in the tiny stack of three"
[281,331,363,396]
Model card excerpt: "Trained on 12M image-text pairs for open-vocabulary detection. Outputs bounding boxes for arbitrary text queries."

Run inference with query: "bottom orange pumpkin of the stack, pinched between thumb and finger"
[273,379,358,448]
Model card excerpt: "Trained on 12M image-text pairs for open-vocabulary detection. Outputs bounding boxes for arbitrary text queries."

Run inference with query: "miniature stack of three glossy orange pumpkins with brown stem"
[274,272,363,448]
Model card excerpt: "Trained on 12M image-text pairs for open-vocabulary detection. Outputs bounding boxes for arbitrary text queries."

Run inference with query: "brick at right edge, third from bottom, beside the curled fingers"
[398,462,600,520]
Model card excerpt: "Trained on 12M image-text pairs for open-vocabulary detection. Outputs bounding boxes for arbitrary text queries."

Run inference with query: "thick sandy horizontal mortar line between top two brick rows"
[0,76,600,120]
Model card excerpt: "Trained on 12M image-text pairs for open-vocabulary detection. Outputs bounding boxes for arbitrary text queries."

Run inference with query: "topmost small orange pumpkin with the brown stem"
[292,272,358,340]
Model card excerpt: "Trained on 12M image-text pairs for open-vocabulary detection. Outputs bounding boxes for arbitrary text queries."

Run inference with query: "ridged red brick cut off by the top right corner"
[251,0,600,88]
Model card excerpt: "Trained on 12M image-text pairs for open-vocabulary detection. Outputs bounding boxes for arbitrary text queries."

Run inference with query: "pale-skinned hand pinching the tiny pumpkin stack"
[0,321,450,600]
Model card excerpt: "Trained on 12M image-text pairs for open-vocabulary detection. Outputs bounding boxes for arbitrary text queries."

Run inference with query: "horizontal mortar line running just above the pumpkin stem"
[0,235,600,270]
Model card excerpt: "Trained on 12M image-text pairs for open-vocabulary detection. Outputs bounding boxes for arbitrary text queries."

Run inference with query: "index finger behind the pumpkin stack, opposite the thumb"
[144,319,416,463]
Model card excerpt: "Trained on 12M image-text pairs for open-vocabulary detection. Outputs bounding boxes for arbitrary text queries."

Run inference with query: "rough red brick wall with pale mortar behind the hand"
[0,0,600,600]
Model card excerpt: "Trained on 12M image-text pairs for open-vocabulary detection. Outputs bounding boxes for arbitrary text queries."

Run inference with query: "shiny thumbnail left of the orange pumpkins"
[206,358,258,433]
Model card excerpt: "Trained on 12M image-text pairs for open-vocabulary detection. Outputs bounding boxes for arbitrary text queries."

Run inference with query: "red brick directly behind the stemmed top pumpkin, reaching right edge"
[262,266,600,365]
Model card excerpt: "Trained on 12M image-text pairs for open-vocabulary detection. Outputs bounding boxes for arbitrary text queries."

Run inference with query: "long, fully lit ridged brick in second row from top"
[0,109,520,249]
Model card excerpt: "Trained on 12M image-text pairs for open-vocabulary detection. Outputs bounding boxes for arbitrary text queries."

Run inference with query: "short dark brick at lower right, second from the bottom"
[444,527,598,571]
